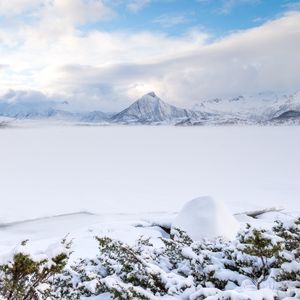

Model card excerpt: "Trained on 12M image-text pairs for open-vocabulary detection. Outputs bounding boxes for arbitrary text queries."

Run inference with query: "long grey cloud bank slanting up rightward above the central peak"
[47,13,300,110]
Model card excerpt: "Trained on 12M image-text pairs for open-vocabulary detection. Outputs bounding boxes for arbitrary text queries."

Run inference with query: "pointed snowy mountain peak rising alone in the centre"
[111,92,210,124]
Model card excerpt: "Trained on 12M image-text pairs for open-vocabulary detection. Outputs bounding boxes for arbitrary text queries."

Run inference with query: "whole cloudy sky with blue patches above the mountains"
[0,0,300,111]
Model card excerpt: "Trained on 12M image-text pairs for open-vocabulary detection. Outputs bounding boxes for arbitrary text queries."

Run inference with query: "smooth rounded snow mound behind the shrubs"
[172,197,239,241]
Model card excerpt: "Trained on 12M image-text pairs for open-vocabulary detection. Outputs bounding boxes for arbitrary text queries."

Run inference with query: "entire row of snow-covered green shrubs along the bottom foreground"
[0,219,300,300]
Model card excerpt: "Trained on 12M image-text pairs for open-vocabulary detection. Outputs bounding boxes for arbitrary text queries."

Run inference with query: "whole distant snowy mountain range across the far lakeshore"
[0,92,300,126]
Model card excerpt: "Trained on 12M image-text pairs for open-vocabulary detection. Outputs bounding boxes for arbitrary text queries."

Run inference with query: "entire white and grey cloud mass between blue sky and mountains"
[0,6,300,111]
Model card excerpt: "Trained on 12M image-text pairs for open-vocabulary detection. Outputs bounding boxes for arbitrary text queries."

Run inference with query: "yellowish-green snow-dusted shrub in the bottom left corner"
[0,239,79,300]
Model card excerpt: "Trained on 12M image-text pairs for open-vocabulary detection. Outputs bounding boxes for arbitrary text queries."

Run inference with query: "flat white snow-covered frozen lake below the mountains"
[0,126,300,223]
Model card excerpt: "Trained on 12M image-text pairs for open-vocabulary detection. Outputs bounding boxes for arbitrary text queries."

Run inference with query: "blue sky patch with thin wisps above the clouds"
[85,0,300,38]
